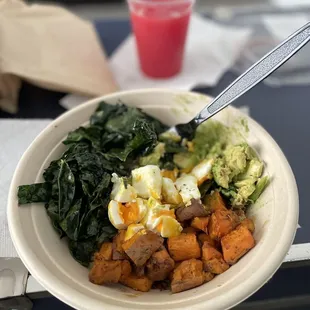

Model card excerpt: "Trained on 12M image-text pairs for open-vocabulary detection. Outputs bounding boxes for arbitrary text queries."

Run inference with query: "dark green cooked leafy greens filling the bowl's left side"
[18,102,167,266]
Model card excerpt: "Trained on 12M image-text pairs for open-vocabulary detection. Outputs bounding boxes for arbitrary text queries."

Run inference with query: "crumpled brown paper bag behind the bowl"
[0,0,117,113]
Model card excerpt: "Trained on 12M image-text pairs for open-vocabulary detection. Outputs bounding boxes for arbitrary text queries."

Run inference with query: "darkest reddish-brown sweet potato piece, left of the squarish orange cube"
[146,247,174,281]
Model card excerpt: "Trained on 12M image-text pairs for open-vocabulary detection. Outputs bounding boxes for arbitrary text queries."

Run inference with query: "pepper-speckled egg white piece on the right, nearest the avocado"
[175,174,201,206]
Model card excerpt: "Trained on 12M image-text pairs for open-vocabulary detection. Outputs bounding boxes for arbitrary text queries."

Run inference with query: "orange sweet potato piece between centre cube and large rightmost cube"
[202,242,229,274]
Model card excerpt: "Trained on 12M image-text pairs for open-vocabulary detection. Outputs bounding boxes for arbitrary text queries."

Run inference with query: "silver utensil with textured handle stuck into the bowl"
[173,23,310,140]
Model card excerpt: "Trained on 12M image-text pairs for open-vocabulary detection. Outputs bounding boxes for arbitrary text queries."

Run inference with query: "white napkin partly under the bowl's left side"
[0,119,50,257]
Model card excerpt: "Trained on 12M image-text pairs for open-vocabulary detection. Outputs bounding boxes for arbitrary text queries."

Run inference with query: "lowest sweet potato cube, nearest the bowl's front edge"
[171,259,205,293]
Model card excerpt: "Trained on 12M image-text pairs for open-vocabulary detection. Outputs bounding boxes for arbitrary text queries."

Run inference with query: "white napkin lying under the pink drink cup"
[110,14,251,89]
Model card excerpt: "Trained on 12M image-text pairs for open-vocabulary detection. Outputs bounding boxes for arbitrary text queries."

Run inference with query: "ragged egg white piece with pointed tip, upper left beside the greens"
[110,173,137,202]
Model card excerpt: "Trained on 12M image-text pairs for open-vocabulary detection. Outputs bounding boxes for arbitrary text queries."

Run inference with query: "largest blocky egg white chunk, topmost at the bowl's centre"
[131,165,162,200]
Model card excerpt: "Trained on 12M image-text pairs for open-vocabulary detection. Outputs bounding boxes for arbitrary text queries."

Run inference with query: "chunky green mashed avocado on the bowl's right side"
[161,120,268,208]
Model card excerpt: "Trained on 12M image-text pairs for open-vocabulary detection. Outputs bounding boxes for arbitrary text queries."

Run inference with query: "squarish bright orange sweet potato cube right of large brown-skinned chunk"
[168,234,201,261]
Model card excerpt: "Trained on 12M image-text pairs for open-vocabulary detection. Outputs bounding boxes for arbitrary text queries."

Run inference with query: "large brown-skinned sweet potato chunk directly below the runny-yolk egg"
[122,229,164,266]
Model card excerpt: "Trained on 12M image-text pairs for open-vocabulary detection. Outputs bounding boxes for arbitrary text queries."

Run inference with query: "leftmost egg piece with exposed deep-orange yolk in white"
[108,198,147,229]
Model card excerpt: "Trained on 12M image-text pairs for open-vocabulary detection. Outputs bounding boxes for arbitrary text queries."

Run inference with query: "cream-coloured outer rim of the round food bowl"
[7,88,299,309]
